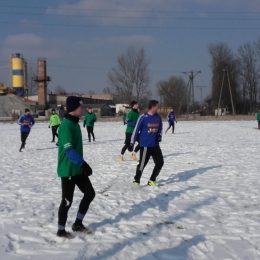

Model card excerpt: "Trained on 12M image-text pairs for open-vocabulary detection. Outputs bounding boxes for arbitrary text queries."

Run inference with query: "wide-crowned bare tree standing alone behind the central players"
[107,47,151,103]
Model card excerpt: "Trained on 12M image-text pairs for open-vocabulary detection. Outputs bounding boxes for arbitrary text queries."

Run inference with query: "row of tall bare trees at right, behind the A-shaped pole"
[207,38,260,114]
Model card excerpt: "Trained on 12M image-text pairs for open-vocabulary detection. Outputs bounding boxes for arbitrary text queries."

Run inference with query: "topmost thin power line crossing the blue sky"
[0,5,260,14]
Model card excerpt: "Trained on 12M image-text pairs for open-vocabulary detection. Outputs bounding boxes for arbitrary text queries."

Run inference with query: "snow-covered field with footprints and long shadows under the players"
[0,121,260,260]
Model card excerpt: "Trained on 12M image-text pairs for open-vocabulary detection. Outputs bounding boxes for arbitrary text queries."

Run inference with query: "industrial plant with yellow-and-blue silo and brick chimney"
[0,53,116,120]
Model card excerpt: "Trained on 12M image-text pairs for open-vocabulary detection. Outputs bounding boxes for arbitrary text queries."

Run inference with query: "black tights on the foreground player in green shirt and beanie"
[58,174,95,226]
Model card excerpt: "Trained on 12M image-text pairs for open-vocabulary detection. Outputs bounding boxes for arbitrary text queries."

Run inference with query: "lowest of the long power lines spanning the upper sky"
[0,22,260,30]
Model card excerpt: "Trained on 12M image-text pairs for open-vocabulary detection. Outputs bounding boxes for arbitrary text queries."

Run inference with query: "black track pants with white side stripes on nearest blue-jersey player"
[134,146,164,182]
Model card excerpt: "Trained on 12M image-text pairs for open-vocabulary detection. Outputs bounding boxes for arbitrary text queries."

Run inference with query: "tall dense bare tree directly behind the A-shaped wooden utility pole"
[208,42,239,111]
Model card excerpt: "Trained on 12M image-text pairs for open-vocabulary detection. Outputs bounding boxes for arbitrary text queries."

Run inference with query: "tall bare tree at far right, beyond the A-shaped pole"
[238,43,259,113]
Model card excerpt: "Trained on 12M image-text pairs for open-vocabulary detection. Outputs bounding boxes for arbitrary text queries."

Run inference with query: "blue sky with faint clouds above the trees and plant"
[0,0,260,100]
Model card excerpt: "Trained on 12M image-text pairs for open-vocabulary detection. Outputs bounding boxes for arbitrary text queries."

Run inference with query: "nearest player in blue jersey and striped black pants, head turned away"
[128,100,164,187]
